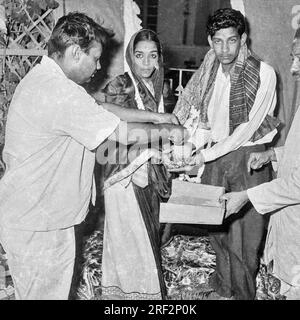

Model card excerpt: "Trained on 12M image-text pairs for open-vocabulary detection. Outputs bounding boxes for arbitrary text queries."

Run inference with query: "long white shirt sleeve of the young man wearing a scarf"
[202,62,277,162]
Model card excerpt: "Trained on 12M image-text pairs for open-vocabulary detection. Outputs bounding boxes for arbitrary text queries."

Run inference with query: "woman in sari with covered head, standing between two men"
[96,29,171,300]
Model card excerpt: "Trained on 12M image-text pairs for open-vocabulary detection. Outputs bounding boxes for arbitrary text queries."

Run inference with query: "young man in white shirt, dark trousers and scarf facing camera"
[174,9,278,300]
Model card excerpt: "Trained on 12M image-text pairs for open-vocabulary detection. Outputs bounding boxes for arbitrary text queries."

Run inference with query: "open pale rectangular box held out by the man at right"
[159,180,225,225]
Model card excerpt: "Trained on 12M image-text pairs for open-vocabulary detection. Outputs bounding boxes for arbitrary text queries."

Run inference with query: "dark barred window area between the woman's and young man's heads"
[157,0,230,68]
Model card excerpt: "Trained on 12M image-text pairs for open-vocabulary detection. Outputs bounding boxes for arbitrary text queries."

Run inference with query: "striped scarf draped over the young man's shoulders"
[174,44,280,141]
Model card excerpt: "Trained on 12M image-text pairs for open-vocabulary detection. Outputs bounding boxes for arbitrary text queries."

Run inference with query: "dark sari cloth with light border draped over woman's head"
[125,29,164,112]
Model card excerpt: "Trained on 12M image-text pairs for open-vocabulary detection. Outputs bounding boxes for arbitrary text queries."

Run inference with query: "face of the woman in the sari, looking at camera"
[133,40,158,79]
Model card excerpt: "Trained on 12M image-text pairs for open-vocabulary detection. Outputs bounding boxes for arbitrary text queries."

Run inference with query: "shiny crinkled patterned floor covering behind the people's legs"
[78,231,285,300]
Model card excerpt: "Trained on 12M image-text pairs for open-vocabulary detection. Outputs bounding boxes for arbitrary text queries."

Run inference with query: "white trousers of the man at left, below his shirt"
[0,227,75,300]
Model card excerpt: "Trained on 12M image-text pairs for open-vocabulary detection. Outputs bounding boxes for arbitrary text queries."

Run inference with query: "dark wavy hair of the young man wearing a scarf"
[206,8,246,37]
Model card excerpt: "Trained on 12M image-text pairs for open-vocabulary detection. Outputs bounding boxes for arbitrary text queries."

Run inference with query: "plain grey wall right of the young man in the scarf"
[244,0,300,145]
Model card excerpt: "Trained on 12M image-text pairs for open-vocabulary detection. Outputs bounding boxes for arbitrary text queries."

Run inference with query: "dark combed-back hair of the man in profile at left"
[48,12,114,57]
